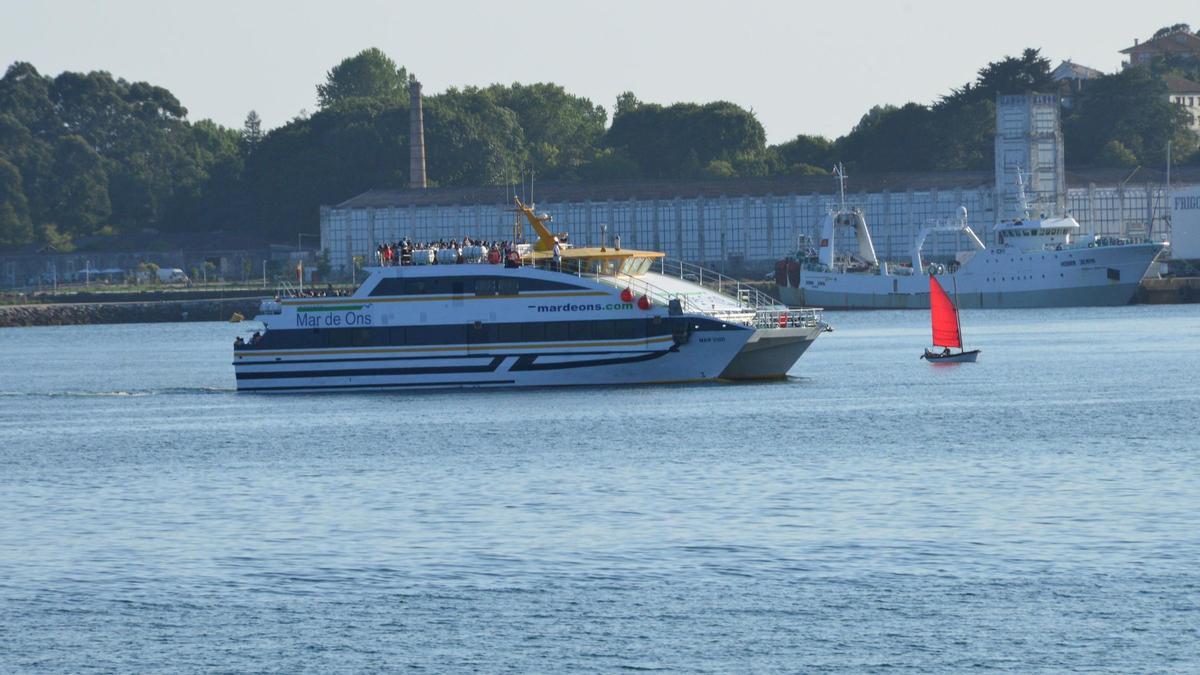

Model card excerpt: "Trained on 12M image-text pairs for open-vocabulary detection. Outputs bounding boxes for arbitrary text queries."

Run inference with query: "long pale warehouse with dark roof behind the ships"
[320,171,1200,274]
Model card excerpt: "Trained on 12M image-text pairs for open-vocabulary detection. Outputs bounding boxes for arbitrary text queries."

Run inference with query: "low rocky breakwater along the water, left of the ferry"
[0,298,260,327]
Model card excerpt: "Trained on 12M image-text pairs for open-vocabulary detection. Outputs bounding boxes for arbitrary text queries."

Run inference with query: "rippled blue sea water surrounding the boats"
[0,305,1200,673]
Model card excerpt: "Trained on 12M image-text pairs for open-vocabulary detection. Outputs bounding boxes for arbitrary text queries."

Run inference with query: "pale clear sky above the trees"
[0,0,1200,143]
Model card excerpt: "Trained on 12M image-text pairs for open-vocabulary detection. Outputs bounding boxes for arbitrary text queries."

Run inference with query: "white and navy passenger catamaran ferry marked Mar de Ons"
[234,201,827,392]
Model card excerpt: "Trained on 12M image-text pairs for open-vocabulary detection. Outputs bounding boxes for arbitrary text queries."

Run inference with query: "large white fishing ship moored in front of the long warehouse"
[775,172,1166,309]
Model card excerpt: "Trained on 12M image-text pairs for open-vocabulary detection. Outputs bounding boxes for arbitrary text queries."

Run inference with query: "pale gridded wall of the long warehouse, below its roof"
[320,185,1169,271]
